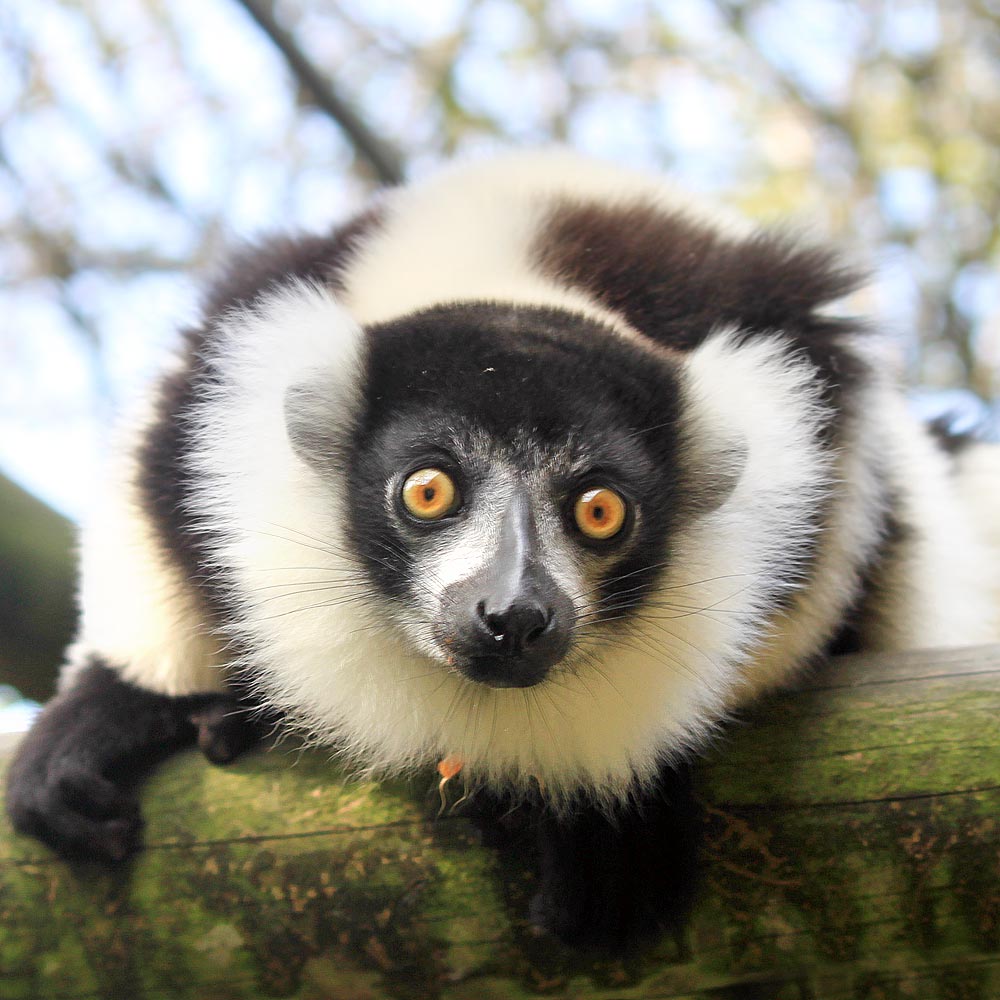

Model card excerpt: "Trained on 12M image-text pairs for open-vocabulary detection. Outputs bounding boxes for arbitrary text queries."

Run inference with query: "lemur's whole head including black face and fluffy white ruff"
[209,285,827,802]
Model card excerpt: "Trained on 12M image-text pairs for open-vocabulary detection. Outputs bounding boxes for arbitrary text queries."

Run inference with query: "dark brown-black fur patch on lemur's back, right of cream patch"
[534,200,867,426]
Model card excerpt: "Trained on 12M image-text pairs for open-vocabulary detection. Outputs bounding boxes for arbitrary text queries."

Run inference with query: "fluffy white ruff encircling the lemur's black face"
[188,290,828,800]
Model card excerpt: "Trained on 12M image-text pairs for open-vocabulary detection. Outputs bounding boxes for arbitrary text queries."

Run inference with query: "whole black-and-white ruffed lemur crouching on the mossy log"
[7,151,1000,940]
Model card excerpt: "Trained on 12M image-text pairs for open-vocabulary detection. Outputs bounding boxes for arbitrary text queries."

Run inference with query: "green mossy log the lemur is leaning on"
[0,647,1000,1000]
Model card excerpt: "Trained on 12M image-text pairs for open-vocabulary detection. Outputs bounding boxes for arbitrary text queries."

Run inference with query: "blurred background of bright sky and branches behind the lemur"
[0,0,1000,729]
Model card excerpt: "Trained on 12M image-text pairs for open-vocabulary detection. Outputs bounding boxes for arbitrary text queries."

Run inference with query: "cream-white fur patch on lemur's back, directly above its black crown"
[344,149,747,335]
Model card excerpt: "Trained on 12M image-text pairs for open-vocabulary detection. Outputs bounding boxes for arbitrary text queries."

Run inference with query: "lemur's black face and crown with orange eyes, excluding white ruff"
[286,304,728,688]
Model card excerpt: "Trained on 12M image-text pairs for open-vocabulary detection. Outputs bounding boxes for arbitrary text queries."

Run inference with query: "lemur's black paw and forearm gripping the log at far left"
[7,663,268,861]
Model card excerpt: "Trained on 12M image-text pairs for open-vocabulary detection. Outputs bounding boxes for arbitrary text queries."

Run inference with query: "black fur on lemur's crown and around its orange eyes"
[346,303,706,605]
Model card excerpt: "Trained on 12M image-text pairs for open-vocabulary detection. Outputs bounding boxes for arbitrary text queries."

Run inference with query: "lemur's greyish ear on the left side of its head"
[284,373,351,474]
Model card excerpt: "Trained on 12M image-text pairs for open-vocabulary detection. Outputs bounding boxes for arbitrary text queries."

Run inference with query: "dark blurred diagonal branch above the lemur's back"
[237,0,403,184]
